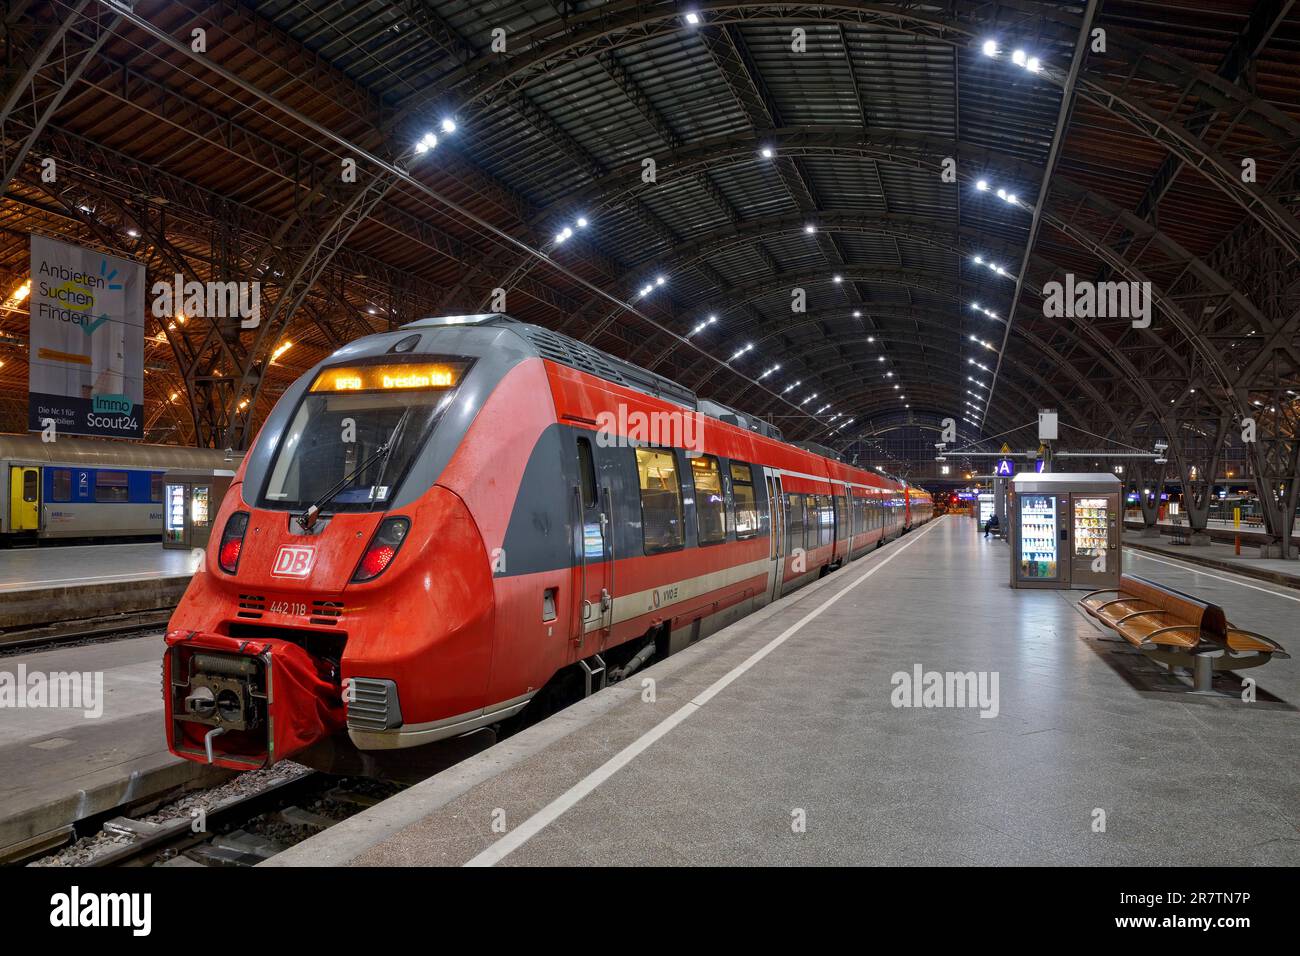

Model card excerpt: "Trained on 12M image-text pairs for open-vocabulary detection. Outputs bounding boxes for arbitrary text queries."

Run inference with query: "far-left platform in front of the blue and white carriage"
[0,542,198,648]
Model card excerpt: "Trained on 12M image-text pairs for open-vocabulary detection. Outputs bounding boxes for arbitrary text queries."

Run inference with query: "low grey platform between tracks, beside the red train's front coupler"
[0,632,229,861]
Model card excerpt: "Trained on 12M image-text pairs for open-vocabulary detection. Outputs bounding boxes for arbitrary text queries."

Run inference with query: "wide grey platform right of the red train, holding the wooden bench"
[264,516,1300,866]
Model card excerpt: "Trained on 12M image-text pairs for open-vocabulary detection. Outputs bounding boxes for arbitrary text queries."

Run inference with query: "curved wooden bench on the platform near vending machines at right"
[1079,575,1290,693]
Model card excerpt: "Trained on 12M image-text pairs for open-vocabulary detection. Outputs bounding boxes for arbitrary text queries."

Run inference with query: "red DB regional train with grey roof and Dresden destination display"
[164,315,932,769]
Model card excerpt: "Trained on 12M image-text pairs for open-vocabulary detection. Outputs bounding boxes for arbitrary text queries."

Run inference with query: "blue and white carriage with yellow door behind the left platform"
[0,434,238,542]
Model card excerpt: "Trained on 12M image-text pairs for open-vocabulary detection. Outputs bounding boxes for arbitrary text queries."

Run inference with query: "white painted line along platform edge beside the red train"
[464,520,939,866]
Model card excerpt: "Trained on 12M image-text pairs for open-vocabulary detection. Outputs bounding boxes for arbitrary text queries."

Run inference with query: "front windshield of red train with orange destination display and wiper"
[259,362,465,511]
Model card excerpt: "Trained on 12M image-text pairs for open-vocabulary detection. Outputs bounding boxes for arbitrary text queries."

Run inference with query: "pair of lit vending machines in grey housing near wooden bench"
[1006,472,1123,591]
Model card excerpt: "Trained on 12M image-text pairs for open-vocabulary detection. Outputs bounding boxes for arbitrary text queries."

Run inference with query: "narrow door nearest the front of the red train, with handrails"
[572,436,614,657]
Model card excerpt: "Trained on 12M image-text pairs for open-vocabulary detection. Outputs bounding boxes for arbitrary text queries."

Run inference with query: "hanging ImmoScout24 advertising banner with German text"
[27,233,144,438]
